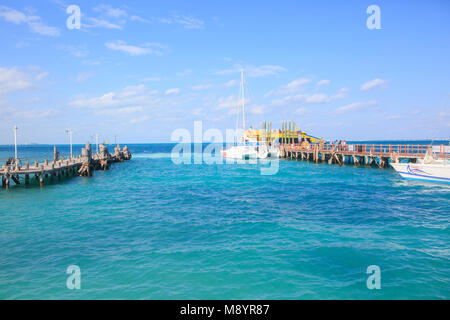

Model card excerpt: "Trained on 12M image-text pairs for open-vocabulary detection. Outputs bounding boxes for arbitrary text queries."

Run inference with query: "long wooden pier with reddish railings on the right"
[280,143,446,168]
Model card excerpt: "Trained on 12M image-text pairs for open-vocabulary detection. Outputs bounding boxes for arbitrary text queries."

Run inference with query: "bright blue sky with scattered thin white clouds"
[0,0,450,144]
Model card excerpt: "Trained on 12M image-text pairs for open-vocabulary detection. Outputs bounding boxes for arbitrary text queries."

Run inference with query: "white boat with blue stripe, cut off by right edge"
[391,149,450,183]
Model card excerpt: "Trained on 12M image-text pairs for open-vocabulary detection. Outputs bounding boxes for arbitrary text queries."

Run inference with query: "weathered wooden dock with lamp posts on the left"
[0,143,132,189]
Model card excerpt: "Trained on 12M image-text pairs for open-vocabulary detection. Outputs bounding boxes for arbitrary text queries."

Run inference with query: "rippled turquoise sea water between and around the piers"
[0,144,450,299]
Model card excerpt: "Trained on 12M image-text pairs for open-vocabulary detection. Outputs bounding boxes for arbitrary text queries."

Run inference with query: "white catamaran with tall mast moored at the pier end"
[222,69,280,160]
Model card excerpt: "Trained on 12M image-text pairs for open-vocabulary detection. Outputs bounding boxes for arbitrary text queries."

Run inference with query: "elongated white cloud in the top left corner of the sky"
[0,6,60,37]
